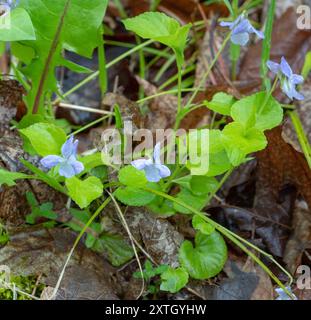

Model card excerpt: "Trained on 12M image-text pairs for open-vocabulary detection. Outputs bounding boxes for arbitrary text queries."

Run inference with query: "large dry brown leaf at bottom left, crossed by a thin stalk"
[0,226,118,300]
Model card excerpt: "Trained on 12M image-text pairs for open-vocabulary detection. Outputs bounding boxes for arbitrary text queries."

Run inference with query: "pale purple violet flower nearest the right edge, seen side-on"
[267,57,304,100]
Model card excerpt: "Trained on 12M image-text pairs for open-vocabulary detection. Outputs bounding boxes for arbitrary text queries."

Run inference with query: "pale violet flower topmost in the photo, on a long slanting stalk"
[220,14,265,46]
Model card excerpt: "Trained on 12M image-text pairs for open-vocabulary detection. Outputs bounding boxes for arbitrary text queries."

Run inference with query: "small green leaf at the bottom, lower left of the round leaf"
[160,267,189,293]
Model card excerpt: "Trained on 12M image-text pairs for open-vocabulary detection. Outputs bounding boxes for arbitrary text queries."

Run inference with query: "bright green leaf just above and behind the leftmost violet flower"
[19,122,66,157]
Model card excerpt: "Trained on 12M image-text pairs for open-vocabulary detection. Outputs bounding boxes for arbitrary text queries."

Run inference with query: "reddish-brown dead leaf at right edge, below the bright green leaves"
[254,127,311,256]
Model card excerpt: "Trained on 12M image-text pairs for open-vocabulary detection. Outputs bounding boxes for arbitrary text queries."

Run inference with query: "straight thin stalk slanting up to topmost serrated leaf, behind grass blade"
[53,40,153,105]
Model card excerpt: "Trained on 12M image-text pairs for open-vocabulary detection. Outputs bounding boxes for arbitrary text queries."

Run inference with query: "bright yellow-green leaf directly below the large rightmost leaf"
[222,122,267,166]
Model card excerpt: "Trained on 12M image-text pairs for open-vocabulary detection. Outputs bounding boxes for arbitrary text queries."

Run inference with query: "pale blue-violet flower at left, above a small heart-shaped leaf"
[40,136,84,178]
